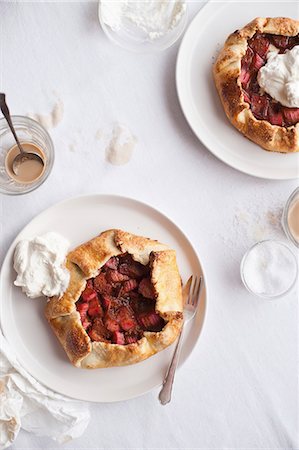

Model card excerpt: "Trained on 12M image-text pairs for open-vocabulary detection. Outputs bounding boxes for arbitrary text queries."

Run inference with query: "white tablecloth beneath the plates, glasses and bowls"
[0,2,298,450]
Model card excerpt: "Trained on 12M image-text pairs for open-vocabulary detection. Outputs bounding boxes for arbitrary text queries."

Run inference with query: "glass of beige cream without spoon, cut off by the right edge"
[282,187,299,248]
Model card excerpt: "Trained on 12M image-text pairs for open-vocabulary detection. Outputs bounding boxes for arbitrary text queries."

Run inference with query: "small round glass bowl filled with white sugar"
[241,240,298,299]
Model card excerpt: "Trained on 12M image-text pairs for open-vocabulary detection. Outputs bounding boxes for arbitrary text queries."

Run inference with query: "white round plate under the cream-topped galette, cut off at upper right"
[176,1,299,180]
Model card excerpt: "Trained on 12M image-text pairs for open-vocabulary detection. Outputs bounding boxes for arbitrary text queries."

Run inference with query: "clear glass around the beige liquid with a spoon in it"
[0,116,54,195]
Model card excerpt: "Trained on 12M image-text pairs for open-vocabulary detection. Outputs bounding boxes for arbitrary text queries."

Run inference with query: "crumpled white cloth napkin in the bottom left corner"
[0,333,90,450]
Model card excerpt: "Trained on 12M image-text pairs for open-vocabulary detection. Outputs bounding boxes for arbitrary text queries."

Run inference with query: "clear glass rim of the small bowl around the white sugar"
[240,239,298,300]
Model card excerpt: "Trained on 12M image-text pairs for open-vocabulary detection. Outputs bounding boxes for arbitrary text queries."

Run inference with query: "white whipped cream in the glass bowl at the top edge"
[101,0,186,40]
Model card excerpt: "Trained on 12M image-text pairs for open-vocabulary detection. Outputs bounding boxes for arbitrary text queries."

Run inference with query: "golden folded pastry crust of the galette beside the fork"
[45,230,183,369]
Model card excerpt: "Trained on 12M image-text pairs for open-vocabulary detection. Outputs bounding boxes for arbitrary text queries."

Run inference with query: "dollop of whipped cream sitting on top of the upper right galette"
[257,45,299,108]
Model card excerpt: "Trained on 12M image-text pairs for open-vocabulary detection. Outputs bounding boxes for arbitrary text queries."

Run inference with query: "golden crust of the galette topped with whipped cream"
[213,17,299,153]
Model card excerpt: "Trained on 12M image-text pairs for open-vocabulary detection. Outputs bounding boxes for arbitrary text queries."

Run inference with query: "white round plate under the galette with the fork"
[0,195,207,402]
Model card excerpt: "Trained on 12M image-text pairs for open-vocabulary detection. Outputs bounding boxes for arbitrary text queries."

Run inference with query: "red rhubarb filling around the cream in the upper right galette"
[239,33,299,127]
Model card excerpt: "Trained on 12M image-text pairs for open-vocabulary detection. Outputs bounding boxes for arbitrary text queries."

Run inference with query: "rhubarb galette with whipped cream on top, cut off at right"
[213,17,299,153]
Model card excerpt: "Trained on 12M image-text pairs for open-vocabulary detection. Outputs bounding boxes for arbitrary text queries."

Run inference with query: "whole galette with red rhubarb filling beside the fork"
[46,230,183,368]
